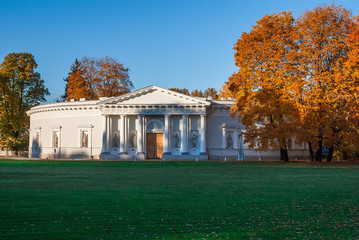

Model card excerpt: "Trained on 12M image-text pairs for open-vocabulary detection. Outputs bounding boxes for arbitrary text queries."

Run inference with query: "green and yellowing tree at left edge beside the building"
[0,53,49,154]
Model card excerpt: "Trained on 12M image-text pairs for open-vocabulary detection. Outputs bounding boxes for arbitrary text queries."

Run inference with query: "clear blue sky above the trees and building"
[0,0,359,102]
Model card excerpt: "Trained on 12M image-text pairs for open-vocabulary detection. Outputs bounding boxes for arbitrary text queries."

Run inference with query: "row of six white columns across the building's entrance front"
[102,114,207,155]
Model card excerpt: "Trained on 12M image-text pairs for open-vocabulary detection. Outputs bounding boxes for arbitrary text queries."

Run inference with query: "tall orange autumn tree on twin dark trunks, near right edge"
[293,4,357,161]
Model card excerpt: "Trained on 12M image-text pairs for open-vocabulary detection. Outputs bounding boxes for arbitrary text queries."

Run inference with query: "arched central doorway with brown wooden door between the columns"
[146,118,164,159]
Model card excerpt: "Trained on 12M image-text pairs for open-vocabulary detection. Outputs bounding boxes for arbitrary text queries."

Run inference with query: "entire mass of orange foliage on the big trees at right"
[221,4,359,160]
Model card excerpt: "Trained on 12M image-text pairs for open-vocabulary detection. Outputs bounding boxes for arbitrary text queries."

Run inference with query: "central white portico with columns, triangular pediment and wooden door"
[99,86,210,159]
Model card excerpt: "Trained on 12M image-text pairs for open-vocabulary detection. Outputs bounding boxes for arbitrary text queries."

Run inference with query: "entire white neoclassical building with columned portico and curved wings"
[27,86,307,160]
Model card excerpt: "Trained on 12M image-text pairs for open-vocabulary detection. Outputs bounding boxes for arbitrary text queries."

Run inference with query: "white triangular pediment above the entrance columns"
[98,86,210,106]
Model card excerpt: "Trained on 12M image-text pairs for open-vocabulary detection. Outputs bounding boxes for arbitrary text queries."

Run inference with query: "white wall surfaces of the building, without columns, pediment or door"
[29,102,309,160]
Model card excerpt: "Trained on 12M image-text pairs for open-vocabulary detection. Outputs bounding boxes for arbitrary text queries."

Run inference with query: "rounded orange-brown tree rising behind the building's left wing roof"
[67,56,134,99]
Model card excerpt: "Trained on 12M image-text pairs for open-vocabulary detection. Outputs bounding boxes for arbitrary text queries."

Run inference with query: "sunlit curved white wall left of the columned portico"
[29,109,103,158]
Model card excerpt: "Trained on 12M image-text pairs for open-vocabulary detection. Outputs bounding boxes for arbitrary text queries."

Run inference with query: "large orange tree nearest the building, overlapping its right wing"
[222,12,297,161]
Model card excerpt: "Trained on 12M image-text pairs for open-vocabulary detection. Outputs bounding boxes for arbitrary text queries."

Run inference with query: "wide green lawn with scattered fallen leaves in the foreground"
[0,160,359,239]
